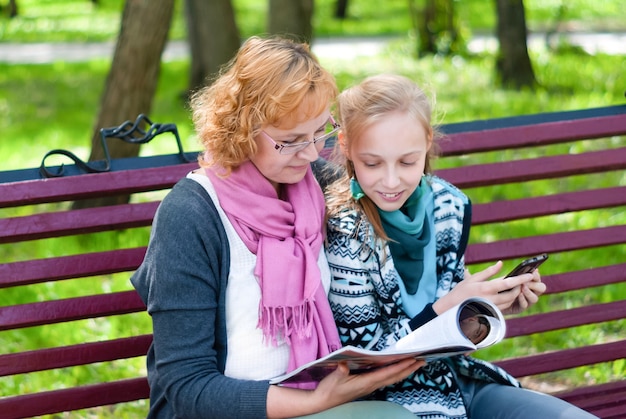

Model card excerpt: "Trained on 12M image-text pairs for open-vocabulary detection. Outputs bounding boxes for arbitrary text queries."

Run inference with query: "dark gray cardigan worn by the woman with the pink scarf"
[131,178,269,419]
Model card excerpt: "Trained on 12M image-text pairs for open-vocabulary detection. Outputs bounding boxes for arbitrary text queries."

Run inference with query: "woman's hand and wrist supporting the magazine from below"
[267,358,425,418]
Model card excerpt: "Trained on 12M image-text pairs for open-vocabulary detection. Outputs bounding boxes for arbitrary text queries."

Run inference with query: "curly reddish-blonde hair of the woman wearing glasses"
[191,36,338,173]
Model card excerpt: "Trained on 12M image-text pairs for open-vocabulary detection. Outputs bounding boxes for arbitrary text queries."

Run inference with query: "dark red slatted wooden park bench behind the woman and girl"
[0,106,626,418]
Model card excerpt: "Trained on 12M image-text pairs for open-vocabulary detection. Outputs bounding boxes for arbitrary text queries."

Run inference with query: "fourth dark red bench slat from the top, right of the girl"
[465,225,626,264]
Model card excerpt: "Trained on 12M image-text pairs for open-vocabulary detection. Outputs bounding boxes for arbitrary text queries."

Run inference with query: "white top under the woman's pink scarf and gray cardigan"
[187,173,330,380]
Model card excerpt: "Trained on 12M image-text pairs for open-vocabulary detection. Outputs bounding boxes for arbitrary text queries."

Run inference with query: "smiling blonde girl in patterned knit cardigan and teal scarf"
[326,75,593,418]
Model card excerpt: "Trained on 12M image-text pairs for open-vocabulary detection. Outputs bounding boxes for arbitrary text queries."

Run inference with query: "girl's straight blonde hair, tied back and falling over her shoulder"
[327,74,439,240]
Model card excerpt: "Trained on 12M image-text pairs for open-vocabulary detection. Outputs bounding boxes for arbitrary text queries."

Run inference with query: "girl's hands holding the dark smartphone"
[433,261,545,314]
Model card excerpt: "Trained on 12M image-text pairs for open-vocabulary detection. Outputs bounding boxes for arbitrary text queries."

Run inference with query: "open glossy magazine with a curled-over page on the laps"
[270,298,506,384]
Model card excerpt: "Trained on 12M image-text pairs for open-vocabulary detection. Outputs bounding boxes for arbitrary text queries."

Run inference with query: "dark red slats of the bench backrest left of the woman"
[0,163,196,417]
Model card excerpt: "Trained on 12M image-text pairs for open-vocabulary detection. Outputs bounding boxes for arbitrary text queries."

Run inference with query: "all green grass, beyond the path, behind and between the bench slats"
[0,0,626,417]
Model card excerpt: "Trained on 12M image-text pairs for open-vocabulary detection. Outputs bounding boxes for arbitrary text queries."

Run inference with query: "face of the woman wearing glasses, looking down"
[250,106,330,195]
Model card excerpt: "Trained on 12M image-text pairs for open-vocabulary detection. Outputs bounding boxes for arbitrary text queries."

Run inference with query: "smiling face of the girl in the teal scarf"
[348,112,431,211]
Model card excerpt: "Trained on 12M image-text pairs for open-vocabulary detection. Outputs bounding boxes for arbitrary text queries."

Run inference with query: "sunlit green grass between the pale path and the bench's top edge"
[0,39,626,170]
